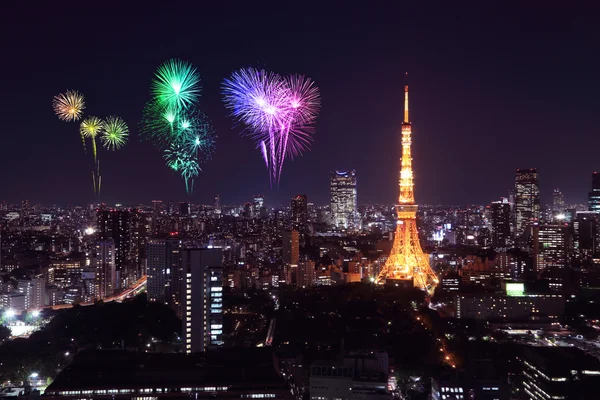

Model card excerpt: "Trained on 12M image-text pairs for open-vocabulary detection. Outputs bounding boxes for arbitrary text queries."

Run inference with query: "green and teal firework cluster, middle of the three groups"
[140,59,216,194]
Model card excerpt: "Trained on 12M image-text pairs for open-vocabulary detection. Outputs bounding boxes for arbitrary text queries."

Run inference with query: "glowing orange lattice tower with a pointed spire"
[376,76,438,293]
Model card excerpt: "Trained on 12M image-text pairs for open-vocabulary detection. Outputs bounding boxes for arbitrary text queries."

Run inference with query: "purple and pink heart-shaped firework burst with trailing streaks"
[222,68,320,185]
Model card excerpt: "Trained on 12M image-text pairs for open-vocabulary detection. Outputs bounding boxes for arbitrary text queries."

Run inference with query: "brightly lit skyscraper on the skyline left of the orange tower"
[331,170,359,229]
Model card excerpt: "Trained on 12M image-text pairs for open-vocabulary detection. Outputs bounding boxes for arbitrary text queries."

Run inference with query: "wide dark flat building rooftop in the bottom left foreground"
[46,349,284,393]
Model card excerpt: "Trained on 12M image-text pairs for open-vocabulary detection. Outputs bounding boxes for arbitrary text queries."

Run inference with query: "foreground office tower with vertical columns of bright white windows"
[181,249,223,353]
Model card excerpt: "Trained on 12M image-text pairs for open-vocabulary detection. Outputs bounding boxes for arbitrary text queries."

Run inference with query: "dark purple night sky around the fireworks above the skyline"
[0,0,600,204]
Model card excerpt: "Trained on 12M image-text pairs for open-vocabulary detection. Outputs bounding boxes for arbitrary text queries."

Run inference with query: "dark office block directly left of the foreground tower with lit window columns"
[146,237,183,315]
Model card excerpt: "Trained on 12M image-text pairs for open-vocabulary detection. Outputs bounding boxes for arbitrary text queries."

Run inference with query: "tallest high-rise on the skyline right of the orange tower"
[515,168,540,237]
